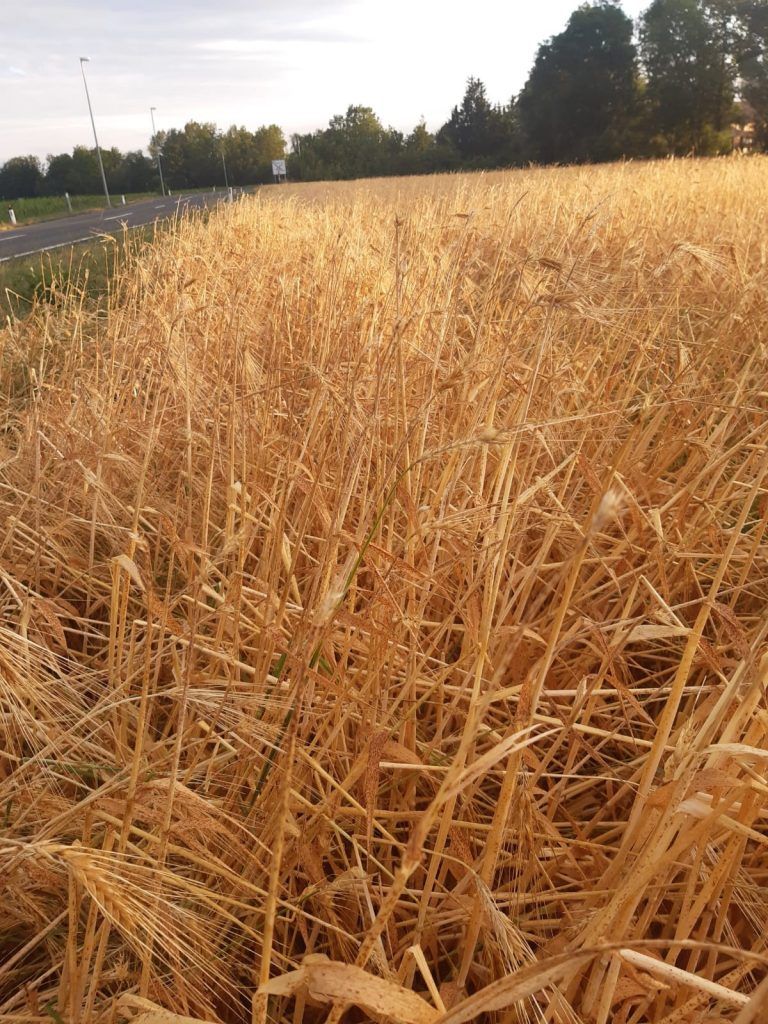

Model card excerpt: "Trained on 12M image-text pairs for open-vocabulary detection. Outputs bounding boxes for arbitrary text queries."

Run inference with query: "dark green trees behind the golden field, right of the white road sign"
[288,0,768,180]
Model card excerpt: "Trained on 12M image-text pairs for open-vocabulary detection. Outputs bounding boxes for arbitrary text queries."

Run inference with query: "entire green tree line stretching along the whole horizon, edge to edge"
[0,0,768,198]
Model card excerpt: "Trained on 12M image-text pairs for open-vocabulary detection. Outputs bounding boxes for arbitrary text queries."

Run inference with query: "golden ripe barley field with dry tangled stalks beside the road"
[0,158,768,1024]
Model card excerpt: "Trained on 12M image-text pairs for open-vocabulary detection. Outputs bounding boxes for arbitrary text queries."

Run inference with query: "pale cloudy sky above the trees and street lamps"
[0,0,648,163]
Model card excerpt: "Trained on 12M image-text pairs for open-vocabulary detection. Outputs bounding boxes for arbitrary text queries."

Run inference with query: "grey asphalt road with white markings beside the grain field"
[0,191,226,263]
